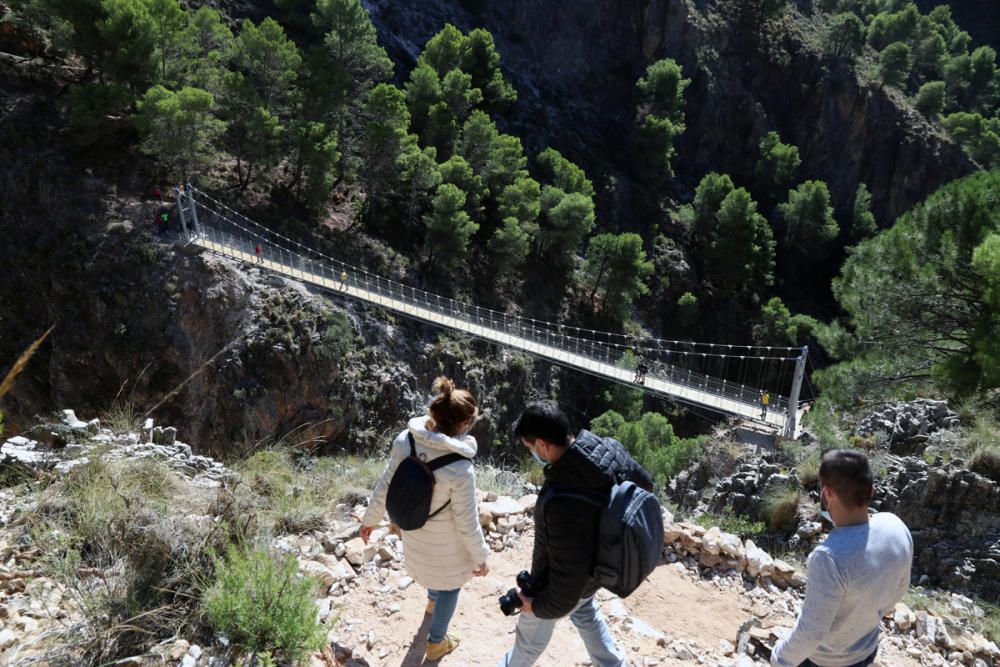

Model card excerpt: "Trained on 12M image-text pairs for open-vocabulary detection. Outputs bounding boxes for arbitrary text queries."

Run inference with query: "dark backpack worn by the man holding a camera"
[538,481,663,598]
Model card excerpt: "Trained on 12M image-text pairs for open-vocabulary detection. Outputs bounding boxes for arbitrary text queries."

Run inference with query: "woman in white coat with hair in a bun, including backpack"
[361,377,490,660]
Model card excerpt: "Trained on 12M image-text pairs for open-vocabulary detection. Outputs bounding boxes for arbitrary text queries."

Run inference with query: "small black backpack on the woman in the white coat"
[385,433,469,530]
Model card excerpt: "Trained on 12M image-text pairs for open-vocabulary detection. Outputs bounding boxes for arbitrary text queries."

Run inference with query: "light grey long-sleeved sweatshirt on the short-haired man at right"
[771,512,913,667]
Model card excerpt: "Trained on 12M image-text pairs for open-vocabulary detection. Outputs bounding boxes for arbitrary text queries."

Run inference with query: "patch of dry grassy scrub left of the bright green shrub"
[21,453,233,665]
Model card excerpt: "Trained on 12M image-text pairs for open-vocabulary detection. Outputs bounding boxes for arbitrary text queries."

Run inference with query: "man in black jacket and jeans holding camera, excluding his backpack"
[496,401,653,667]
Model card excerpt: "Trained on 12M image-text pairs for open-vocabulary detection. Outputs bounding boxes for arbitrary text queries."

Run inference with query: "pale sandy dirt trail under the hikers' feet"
[331,532,920,667]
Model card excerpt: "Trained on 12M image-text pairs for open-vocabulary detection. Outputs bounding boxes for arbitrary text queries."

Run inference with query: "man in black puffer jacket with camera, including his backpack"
[497,401,663,667]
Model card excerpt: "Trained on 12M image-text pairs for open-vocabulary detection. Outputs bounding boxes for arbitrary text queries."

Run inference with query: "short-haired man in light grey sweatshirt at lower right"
[771,449,913,667]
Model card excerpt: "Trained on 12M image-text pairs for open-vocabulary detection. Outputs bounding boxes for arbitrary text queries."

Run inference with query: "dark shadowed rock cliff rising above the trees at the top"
[366,0,973,226]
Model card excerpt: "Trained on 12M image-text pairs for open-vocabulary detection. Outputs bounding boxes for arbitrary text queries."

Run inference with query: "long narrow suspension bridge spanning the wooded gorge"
[175,185,808,438]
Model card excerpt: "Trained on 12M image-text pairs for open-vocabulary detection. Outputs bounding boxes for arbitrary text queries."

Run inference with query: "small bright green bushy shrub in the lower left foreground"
[204,547,326,662]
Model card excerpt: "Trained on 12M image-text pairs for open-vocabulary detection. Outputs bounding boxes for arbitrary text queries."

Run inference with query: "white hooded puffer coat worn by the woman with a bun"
[361,416,490,591]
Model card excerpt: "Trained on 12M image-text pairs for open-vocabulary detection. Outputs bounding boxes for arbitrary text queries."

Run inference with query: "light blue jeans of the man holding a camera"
[497,596,627,667]
